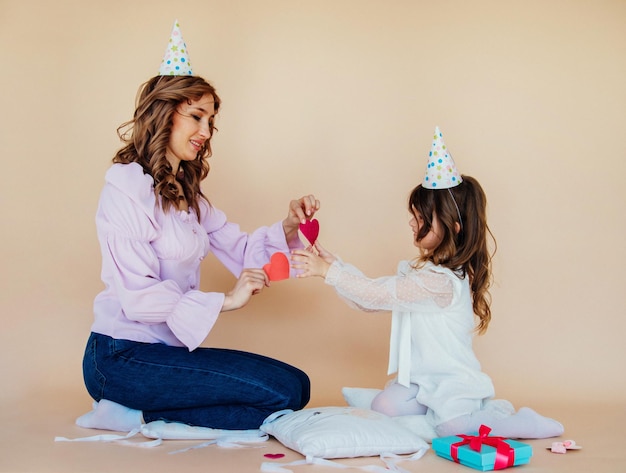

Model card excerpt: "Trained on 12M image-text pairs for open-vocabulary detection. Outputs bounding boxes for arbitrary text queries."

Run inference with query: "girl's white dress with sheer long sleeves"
[326,260,494,425]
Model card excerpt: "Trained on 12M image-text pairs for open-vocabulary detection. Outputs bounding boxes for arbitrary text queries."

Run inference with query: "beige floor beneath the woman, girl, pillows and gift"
[0,393,626,473]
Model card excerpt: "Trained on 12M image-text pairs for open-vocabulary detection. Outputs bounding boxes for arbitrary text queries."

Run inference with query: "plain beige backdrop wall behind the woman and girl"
[0,0,626,413]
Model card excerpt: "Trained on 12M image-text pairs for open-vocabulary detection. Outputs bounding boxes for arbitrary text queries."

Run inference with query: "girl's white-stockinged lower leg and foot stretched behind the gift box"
[436,407,564,439]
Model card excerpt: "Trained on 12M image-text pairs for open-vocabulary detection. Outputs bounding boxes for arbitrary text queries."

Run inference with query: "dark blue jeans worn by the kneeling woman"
[83,333,310,430]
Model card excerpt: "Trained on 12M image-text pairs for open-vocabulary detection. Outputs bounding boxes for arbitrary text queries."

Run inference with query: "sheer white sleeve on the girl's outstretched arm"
[326,261,453,312]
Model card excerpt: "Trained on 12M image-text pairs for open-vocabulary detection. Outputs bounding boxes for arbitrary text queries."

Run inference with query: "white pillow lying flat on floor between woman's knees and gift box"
[260,407,429,459]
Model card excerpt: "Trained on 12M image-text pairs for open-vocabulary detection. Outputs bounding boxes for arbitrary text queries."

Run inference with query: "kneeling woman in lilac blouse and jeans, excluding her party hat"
[76,75,319,431]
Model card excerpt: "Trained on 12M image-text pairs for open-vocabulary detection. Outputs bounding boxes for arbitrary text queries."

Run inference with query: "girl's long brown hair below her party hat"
[408,175,496,334]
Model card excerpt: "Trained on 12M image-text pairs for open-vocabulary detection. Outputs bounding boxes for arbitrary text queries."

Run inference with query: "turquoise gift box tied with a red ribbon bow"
[432,426,533,471]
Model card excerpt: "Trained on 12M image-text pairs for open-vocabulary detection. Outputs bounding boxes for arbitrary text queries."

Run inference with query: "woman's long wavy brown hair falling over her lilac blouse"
[113,76,221,216]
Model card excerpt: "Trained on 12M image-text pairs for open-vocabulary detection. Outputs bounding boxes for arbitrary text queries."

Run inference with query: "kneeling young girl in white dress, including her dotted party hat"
[292,129,563,438]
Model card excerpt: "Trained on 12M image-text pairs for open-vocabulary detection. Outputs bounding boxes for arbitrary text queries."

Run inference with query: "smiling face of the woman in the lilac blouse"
[165,94,215,174]
